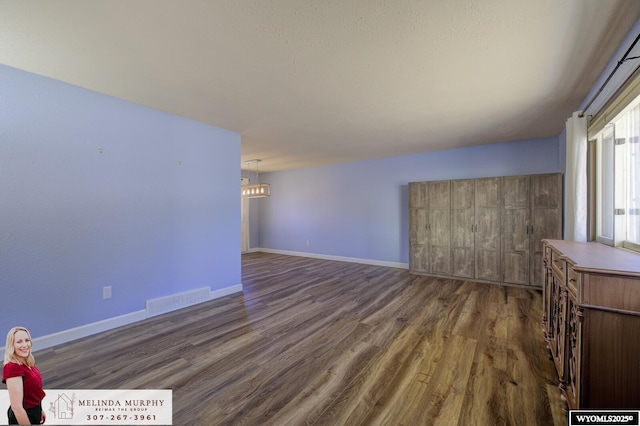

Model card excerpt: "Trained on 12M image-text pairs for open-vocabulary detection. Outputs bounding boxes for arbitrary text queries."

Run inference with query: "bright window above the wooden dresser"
[595,96,640,251]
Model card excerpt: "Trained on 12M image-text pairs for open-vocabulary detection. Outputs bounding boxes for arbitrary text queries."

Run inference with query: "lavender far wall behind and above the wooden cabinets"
[252,137,563,264]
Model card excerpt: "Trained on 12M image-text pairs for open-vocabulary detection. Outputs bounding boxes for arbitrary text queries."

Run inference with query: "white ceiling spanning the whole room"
[0,0,640,171]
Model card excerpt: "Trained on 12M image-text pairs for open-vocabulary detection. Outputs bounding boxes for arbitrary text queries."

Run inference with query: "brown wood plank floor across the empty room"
[35,253,567,426]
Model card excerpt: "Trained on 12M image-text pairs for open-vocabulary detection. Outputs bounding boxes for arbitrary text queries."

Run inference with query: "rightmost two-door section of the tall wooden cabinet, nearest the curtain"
[502,173,562,286]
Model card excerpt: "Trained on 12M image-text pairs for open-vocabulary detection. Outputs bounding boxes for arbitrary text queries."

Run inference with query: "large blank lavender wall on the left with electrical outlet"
[0,65,241,337]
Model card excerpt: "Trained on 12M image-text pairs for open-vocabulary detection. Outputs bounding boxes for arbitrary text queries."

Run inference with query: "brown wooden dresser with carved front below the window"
[542,240,640,409]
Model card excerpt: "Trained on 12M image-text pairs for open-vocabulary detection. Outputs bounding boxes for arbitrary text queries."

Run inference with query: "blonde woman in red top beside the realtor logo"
[2,327,46,425]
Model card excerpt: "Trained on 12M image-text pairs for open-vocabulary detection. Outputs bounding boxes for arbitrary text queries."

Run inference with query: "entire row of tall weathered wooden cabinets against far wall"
[409,174,562,286]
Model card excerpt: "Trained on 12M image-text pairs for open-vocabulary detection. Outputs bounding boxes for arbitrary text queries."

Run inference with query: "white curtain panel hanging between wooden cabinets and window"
[564,112,588,241]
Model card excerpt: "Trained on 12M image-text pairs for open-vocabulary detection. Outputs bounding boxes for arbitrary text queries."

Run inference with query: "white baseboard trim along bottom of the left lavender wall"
[18,284,242,353]
